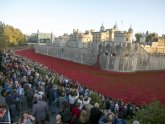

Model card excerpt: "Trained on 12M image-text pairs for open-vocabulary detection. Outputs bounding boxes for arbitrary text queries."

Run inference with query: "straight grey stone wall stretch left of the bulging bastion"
[35,45,97,66]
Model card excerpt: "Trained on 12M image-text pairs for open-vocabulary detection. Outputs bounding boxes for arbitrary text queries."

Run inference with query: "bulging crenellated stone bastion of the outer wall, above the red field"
[100,43,139,72]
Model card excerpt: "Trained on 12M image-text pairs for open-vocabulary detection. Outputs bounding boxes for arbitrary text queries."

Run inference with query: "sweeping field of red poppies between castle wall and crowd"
[17,49,165,105]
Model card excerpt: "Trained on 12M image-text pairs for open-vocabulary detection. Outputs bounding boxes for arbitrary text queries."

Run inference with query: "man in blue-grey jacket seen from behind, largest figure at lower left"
[32,96,48,124]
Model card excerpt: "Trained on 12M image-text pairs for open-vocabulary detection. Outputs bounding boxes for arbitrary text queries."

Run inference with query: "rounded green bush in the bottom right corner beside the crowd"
[133,101,165,124]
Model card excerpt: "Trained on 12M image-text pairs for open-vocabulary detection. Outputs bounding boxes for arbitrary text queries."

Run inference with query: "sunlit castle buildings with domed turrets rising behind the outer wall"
[54,23,133,48]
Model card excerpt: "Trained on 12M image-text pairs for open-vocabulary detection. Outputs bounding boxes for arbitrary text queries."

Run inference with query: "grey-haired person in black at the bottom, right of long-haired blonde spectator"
[89,103,103,124]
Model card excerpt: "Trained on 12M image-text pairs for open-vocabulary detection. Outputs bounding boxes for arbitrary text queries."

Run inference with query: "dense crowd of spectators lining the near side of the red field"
[0,50,138,124]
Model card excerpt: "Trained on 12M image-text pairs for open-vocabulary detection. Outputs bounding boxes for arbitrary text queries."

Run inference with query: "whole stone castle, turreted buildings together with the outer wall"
[35,24,165,72]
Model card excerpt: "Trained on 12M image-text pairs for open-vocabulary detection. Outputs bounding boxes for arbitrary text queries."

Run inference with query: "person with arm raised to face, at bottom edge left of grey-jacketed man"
[18,112,35,124]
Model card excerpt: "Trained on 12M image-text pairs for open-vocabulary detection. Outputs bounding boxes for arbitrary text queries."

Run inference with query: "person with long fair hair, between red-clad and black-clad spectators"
[76,110,90,124]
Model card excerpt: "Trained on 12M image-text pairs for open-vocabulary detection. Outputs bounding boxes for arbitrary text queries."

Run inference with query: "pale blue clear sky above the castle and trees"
[0,0,165,36]
